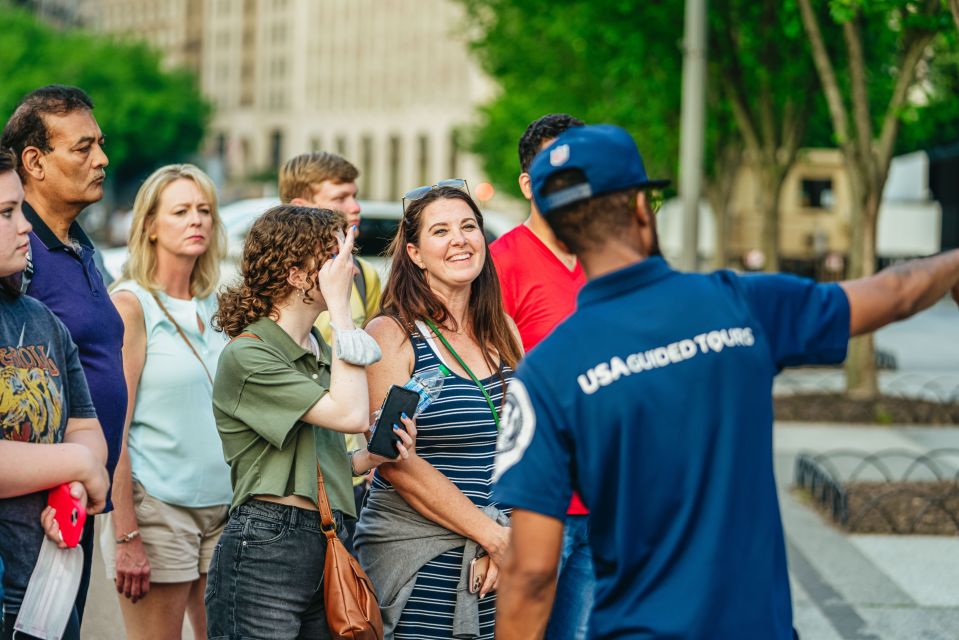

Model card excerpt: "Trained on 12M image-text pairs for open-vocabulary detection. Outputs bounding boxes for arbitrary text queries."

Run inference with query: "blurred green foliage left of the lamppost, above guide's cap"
[463,0,683,197]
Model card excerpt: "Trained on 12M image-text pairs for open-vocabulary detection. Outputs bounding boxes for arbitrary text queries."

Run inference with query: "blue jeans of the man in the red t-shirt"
[546,516,596,640]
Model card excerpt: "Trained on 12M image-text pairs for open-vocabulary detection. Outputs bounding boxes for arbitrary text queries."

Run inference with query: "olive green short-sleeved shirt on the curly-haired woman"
[213,318,356,517]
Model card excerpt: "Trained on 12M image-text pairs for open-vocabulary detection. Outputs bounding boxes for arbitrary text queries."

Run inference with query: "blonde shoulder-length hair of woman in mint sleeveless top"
[120,164,226,298]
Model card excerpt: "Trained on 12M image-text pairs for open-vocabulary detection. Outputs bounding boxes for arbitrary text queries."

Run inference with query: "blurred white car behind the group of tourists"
[103,198,518,282]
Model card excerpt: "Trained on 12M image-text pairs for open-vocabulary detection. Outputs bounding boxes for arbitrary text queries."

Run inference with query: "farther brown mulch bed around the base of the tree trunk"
[773,393,959,425]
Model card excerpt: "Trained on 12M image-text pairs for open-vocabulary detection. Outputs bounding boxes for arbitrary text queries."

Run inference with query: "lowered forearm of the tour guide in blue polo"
[496,509,563,640]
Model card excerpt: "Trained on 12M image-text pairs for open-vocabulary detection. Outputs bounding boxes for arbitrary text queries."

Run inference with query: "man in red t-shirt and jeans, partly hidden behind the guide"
[490,113,595,640]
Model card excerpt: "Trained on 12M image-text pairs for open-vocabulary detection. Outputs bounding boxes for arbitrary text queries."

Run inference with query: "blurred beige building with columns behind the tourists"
[56,0,492,200]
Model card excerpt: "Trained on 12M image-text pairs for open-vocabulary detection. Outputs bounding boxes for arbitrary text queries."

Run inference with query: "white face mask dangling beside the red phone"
[13,537,83,640]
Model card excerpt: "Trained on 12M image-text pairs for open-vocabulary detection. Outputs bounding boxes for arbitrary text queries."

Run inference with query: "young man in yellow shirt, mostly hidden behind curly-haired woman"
[279,151,381,343]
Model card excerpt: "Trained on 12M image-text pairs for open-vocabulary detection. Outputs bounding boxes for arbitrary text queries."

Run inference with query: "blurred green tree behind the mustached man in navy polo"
[0,2,211,184]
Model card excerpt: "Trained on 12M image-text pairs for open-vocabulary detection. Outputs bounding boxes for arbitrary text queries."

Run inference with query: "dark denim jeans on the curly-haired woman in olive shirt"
[204,500,346,640]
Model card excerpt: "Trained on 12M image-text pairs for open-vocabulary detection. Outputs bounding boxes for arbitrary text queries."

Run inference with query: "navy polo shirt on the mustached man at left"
[23,202,127,508]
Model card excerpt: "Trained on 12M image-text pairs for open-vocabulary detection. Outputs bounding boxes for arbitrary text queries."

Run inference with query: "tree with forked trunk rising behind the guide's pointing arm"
[797,0,956,398]
